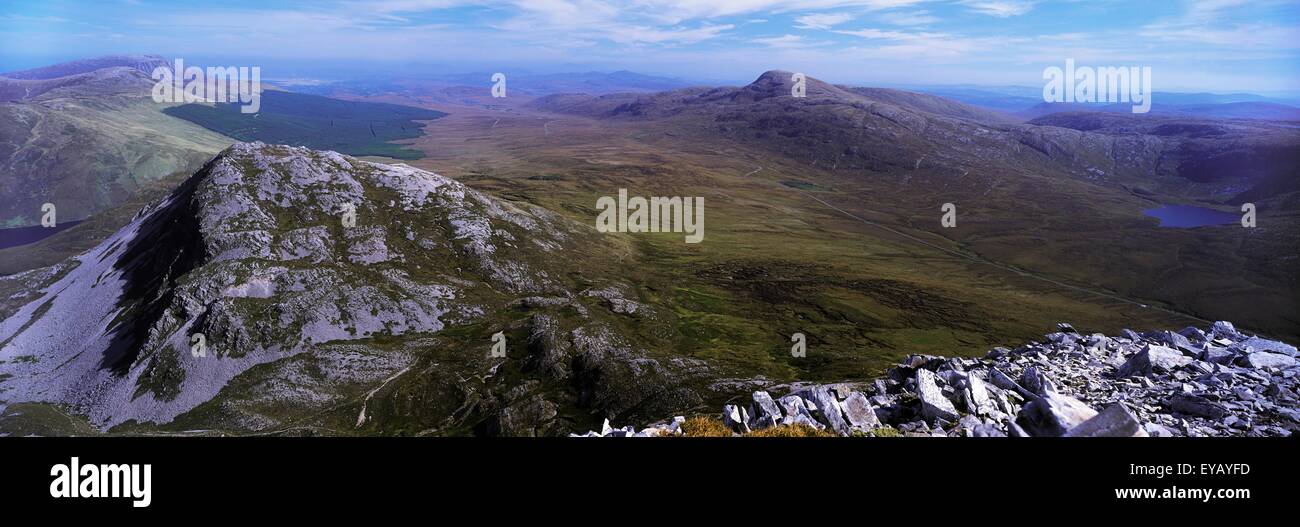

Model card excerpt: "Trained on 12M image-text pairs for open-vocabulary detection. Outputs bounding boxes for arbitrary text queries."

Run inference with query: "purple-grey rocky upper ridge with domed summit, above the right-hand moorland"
[529,72,1300,202]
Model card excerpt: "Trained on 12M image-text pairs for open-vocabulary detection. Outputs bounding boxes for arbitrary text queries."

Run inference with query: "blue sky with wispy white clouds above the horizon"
[0,0,1300,95]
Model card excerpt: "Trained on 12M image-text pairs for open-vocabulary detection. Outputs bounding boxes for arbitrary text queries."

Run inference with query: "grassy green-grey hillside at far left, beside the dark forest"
[0,57,231,226]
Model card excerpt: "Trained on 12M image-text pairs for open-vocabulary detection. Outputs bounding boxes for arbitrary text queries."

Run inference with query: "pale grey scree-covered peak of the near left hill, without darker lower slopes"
[0,143,573,426]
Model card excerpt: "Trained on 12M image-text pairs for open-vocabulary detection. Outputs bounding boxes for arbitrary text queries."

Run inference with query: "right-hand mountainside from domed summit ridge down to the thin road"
[530,72,1300,338]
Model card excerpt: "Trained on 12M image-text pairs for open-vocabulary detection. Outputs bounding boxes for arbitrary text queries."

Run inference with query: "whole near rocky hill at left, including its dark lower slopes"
[0,143,709,435]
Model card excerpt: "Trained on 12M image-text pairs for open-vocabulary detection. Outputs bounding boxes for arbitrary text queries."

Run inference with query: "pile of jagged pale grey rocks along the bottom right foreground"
[584,321,1300,437]
